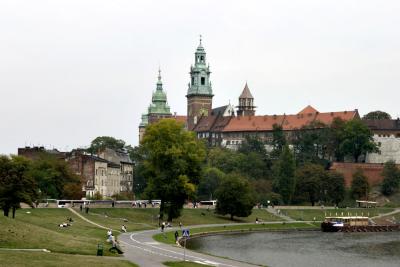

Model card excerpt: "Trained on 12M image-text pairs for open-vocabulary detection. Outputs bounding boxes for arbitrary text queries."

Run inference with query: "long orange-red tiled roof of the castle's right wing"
[223,107,358,132]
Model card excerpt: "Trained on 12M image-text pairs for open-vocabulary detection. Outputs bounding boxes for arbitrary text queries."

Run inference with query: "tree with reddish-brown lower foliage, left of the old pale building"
[29,154,82,199]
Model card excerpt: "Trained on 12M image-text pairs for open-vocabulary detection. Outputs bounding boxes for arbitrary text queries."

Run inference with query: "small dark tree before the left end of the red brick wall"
[321,171,346,206]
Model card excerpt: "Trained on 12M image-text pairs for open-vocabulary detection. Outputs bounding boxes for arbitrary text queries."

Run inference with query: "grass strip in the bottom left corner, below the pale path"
[0,251,137,267]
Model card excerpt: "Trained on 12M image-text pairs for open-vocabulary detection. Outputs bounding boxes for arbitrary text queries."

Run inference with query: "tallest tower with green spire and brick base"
[186,35,214,130]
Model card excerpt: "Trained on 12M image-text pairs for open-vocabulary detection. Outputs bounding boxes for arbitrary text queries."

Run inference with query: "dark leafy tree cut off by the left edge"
[0,156,38,218]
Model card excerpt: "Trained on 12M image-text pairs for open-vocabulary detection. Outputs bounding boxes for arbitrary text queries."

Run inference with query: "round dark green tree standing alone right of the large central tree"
[215,174,255,220]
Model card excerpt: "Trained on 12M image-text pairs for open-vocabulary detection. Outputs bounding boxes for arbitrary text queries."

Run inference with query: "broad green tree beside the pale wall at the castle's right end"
[340,120,379,162]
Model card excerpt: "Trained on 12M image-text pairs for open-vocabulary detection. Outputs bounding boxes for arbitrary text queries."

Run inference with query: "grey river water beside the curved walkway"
[187,231,400,267]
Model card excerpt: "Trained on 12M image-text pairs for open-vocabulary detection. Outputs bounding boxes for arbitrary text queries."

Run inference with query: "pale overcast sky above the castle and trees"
[0,0,400,154]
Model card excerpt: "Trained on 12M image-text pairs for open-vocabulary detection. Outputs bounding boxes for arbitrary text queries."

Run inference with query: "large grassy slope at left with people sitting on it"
[0,209,120,256]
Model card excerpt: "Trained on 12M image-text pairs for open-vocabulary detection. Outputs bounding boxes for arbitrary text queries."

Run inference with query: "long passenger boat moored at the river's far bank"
[321,216,400,232]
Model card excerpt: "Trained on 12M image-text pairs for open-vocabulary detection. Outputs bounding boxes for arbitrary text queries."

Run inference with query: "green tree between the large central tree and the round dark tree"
[197,167,225,200]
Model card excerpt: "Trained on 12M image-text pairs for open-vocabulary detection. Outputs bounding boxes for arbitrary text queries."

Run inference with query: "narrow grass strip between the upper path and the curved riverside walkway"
[153,223,319,244]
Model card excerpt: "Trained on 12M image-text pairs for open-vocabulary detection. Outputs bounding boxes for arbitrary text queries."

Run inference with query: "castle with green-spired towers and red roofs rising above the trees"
[139,38,360,149]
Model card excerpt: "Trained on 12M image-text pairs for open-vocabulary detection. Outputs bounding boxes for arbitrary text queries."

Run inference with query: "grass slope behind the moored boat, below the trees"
[281,208,393,221]
